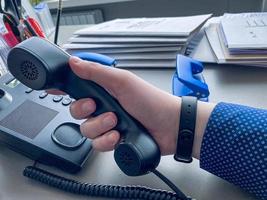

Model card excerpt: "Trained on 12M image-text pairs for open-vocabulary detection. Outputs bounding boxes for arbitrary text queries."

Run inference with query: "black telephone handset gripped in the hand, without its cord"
[7,37,161,176]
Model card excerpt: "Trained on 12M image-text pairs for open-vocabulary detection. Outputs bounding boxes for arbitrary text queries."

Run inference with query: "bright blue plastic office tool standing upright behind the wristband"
[172,55,209,101]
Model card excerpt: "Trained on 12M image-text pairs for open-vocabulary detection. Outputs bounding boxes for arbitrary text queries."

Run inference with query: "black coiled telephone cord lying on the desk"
[23,166,191,200]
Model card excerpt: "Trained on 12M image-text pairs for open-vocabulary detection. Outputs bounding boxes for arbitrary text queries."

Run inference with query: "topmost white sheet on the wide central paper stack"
[75,14,211,37]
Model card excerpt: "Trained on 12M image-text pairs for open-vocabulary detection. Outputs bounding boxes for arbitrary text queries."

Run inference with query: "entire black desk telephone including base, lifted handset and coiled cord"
[0,37,193,199]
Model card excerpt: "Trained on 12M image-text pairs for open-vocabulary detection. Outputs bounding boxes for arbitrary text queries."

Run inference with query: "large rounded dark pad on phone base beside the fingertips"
[52,123,86,150]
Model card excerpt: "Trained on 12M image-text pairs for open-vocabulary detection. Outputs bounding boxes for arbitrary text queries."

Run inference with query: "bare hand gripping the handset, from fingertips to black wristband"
[52,57,180,155]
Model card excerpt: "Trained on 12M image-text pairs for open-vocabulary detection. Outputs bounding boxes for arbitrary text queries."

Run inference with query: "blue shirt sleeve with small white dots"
[200,103,267,200]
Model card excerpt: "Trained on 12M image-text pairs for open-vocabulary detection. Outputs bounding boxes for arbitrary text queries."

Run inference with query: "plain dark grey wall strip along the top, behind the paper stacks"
[52,0,262,20]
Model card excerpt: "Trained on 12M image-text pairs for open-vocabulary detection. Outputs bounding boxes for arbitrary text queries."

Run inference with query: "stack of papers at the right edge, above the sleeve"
[205,13,267,67]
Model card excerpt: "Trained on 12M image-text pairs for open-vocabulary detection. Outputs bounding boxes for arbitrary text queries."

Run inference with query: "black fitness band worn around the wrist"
[174,96,197,163]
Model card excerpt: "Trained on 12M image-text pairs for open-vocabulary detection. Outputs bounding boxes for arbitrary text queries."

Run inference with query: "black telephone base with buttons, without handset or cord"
[0,73,92,173]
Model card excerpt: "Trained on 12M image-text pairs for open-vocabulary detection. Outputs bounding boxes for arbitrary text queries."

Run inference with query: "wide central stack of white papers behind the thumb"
[63,14,211,68]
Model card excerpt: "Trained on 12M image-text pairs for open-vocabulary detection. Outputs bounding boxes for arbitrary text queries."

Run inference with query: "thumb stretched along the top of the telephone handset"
[69,56,129,97]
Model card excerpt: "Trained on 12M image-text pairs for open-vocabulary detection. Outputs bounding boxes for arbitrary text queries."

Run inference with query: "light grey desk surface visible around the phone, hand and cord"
[0,26,267,200]
